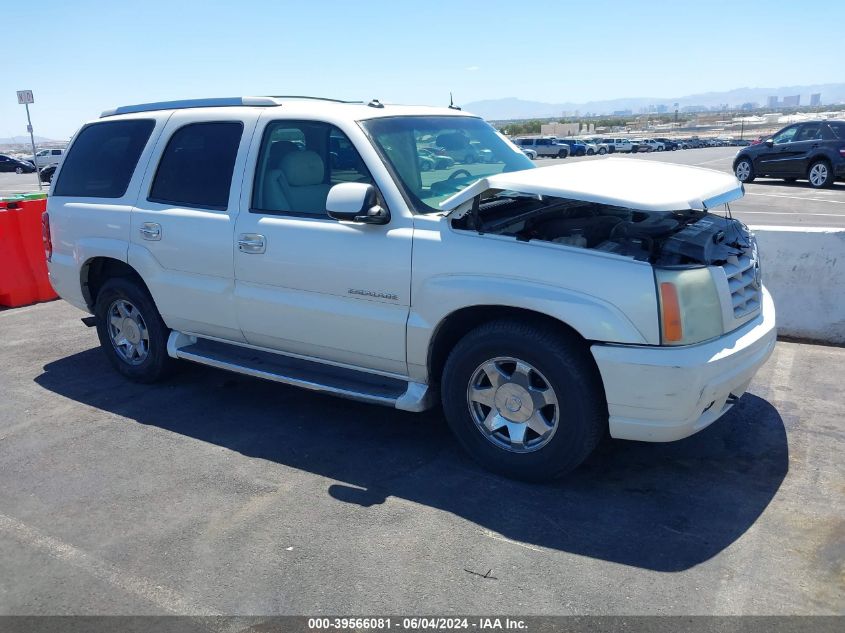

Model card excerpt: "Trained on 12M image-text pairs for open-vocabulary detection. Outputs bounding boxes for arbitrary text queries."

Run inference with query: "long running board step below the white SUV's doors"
[167,331,436,411]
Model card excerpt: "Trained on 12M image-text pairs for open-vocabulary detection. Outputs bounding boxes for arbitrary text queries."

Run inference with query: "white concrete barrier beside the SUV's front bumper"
[751,226,845,345]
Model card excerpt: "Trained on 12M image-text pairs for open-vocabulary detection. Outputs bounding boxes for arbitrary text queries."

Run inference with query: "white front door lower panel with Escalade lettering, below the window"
[235,217,412,375]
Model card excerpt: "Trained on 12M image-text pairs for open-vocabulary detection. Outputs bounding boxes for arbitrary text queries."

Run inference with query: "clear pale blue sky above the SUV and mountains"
[0,0,845,139]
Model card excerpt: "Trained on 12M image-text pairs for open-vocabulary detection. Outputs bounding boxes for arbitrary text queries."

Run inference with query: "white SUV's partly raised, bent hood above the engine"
[440,158,744,218]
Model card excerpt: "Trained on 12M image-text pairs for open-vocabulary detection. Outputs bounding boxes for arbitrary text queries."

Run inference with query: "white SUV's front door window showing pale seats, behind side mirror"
[250,121,373,217]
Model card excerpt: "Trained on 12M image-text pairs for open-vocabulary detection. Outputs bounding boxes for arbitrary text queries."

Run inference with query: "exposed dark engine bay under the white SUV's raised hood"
[452,192,751,266]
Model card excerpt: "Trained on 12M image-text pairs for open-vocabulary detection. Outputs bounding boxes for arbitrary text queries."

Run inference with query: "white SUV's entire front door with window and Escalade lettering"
[234,116,413,376]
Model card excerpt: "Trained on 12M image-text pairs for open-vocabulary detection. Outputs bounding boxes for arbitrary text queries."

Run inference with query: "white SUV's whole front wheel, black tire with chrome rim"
[441,320,607,481]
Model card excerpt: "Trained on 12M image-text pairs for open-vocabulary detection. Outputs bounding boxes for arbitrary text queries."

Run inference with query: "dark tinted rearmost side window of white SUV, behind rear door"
[53,119,155,198]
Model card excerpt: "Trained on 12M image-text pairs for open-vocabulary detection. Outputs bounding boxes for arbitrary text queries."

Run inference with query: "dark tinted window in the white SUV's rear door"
[148,121,244,211]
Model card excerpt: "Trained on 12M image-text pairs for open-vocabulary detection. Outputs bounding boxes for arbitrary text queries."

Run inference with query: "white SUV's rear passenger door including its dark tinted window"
[129,108,257,341]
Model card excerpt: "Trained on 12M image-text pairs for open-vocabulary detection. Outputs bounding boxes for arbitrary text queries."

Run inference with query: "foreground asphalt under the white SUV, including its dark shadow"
[0,298,845,615]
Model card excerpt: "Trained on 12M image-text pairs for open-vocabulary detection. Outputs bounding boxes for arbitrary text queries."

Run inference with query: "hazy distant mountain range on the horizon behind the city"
[461,83,845,121]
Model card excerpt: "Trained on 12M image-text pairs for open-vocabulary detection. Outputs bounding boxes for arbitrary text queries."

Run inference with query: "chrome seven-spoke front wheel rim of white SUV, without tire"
[467,356,560,453]
